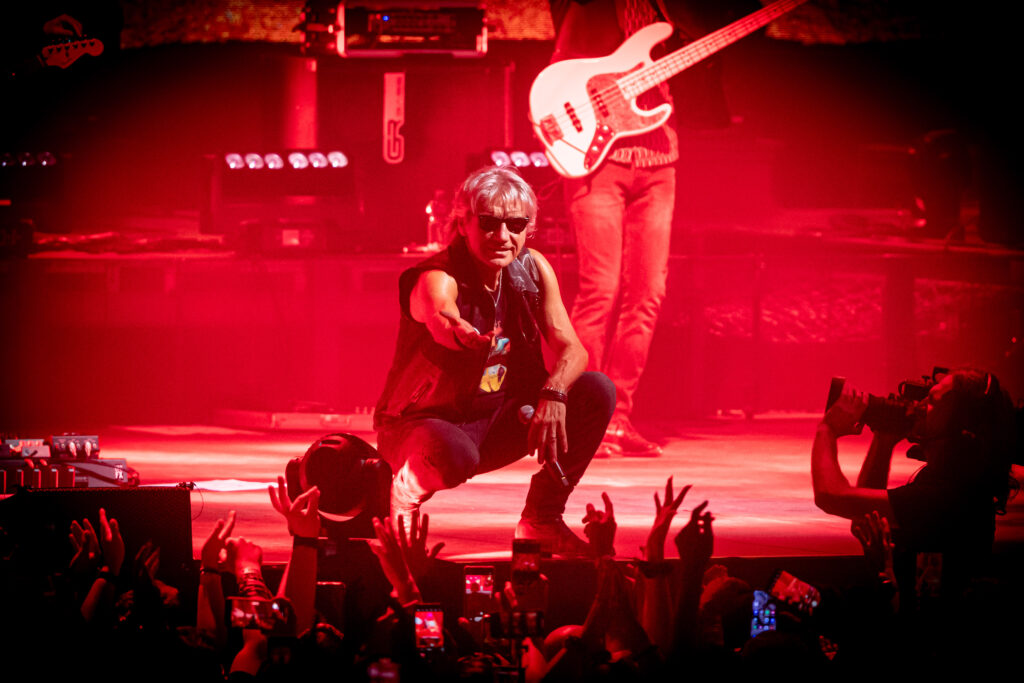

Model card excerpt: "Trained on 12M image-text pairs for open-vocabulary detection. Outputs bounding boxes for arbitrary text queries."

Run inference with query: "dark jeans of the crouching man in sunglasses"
[378,373,615,519]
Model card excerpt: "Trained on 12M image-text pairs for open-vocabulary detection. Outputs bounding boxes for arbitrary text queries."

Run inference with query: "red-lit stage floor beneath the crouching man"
[100,416,1024,562]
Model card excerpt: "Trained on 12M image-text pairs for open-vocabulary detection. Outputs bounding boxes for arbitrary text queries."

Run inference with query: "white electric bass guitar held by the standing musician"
[529,0,807,178]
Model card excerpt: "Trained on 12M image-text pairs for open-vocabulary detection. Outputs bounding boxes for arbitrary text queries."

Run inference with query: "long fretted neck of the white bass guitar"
[618,0,807,97]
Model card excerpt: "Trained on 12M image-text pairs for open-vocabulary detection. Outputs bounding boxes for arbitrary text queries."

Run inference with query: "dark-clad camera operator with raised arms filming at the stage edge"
[811,370,1017,608]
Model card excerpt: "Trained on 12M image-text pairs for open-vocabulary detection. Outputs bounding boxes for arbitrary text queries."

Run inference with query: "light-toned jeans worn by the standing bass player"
[565,162,676,416]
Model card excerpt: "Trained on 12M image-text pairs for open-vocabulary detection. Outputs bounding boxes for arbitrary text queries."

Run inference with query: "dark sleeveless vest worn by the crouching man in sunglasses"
[374,238,548,430]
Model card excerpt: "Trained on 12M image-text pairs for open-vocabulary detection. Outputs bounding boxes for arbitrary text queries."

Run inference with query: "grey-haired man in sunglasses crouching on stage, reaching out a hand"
[374,167,615,555]
